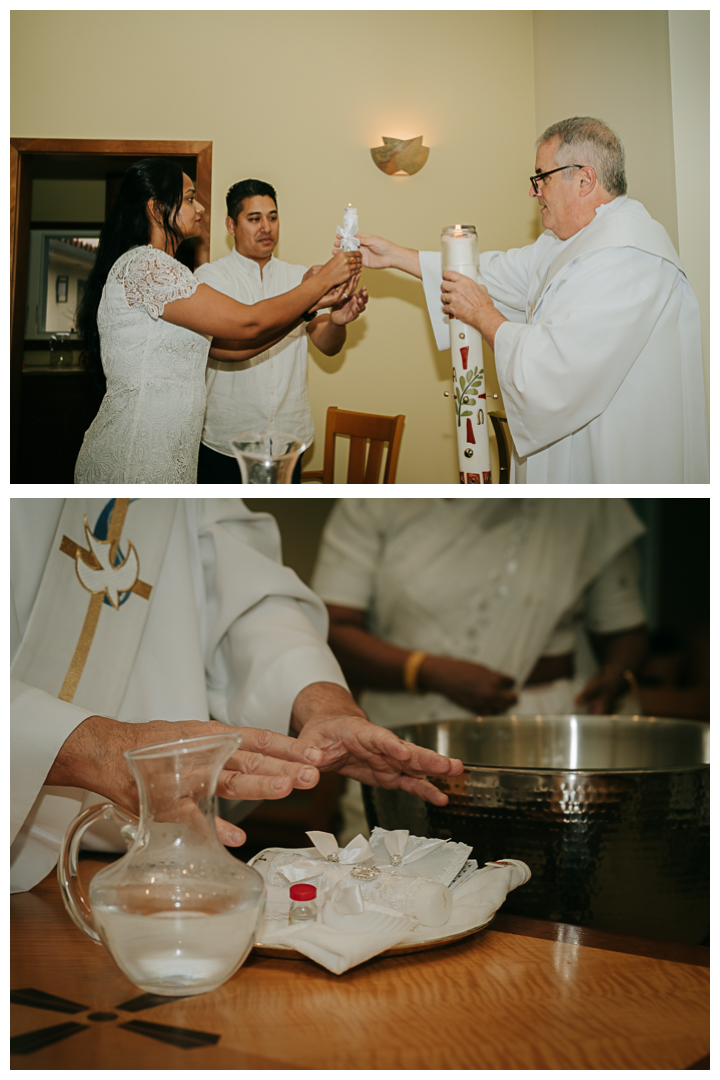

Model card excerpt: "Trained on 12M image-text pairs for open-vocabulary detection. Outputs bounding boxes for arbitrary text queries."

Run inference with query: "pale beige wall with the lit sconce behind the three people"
[11,11,708,484]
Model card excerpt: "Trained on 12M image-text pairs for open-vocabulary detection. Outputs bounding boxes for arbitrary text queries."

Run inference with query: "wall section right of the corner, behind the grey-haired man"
[533,11,710,416]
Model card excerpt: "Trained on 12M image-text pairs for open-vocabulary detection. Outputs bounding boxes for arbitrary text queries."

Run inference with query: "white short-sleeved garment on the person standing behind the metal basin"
[312,499,646,727]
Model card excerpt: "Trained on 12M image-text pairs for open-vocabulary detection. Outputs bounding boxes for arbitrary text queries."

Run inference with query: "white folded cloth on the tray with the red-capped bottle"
[250,831,530,974]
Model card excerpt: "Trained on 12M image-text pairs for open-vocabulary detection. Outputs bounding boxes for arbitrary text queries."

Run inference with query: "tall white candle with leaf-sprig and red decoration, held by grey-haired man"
[440,225,491,484]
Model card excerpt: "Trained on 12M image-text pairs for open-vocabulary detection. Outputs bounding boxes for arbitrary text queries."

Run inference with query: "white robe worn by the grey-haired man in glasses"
[420,195,708,484]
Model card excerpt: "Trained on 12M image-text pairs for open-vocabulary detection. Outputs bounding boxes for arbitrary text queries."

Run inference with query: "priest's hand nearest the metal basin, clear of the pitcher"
[293,683,463,806]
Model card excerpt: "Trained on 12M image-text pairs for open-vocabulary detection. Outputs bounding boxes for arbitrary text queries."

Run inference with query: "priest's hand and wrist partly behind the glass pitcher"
[45,716,324,847]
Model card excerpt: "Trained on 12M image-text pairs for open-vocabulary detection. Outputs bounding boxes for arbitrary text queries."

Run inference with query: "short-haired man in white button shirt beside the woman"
[195,179,367,484]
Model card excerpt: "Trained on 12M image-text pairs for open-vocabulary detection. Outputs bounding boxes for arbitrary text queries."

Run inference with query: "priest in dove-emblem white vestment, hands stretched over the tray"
[11,499,462,891]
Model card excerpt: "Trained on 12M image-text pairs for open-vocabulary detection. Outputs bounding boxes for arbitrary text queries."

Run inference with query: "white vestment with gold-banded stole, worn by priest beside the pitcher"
[11,499,345,892]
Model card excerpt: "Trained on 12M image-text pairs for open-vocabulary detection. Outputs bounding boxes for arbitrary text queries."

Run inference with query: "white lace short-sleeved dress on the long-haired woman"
[74,245,209,484]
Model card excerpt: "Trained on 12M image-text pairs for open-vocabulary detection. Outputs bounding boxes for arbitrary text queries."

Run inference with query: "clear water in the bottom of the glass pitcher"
[93,889,262,997]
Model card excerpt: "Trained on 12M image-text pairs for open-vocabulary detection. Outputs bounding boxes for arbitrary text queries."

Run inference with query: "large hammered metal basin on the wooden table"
[363,715,710,944]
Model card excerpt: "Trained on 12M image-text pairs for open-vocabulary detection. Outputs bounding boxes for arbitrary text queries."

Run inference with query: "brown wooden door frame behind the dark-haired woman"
[10,138,213,470]
